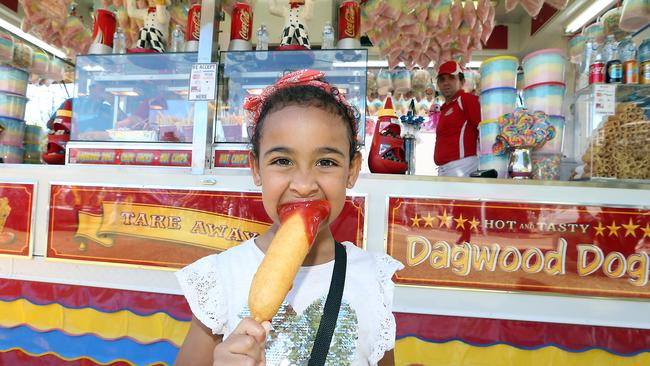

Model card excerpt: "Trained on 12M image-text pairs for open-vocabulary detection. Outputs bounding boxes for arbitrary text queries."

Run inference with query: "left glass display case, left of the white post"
[71,53,197,143]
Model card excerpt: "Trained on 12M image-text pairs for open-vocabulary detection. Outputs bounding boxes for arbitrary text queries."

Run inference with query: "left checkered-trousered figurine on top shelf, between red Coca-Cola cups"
[126,0,170,52]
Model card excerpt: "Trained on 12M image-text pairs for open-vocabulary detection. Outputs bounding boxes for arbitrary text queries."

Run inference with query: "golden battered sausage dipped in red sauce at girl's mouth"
[248,200,330,323]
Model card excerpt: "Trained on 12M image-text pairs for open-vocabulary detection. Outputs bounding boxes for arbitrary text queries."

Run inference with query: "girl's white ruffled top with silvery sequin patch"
[176,239,404,366]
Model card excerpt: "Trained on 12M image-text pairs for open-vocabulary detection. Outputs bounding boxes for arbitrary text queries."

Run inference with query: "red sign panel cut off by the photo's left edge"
[0,183,34,257]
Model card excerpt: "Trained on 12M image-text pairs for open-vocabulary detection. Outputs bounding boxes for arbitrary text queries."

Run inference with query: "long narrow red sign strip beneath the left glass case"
[68,148,192,167]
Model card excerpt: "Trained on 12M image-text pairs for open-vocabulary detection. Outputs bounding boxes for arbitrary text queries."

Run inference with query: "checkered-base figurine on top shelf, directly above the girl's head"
[269,0,313,49]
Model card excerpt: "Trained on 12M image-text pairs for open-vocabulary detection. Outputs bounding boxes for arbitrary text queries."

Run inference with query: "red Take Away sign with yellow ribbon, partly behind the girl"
[47,185,365,268]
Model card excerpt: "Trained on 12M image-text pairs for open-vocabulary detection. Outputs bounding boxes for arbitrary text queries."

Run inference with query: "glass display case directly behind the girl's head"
[214,50,368,144]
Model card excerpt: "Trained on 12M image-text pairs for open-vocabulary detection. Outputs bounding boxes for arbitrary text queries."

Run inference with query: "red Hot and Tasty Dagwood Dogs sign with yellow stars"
[387,197,650,298]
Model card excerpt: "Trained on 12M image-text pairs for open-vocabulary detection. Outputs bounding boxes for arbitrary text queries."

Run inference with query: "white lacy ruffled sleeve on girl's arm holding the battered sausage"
[176,255,228,334]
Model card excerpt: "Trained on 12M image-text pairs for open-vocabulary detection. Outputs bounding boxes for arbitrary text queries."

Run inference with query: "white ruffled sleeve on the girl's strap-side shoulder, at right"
[368,253,404,365]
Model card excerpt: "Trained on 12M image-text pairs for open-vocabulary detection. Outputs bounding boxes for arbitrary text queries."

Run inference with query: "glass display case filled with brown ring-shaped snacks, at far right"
[573,84,650,180]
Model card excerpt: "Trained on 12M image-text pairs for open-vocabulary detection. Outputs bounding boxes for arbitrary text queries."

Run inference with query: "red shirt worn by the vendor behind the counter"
[433,89,481,166]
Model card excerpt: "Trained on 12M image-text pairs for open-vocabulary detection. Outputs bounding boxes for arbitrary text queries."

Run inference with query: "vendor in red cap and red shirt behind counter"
[433,61,481,177]
